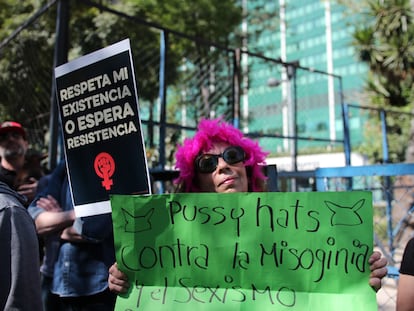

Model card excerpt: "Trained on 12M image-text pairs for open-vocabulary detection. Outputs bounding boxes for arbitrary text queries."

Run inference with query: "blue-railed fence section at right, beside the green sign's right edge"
[315,164,414,310]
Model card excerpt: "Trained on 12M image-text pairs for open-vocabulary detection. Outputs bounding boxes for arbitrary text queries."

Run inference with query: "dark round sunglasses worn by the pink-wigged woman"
[195,146,246,173]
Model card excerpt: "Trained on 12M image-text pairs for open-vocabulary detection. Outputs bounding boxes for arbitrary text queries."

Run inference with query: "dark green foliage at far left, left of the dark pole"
[0,1,55,141]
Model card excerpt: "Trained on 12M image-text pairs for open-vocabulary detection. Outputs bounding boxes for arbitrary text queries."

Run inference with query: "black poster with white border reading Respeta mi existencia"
[55,39,150,217]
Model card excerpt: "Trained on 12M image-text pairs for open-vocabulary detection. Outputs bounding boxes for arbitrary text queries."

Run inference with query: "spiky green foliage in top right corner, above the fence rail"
[354,0,414,107]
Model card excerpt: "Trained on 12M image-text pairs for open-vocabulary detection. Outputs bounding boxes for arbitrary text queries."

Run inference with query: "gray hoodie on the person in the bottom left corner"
[0,182,43,311]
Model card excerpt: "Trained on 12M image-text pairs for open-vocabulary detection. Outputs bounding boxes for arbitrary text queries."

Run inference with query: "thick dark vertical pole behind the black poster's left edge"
[48,0,69,170]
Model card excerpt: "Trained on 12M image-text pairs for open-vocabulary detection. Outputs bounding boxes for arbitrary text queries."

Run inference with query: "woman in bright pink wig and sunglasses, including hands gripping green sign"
[108,119,387,293]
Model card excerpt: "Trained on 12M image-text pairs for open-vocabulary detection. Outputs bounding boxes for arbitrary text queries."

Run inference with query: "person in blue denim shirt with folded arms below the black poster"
[28,161,116,311]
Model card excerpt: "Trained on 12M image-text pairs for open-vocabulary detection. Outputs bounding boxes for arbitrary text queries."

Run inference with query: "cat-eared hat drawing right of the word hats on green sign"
[325,199,365,226]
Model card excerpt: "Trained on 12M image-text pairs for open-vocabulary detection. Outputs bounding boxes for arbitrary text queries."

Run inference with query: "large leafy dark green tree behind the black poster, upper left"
[0,0,244,152]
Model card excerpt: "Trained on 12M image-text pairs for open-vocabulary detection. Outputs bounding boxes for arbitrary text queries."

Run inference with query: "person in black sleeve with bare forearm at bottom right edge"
[397,238,414,311]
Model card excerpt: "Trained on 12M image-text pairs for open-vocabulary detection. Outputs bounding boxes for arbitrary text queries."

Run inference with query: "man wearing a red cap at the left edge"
[0,121,37,203]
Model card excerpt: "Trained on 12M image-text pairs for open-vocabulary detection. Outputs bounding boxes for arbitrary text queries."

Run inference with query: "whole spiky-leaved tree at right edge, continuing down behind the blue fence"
[343,0,414,162]
